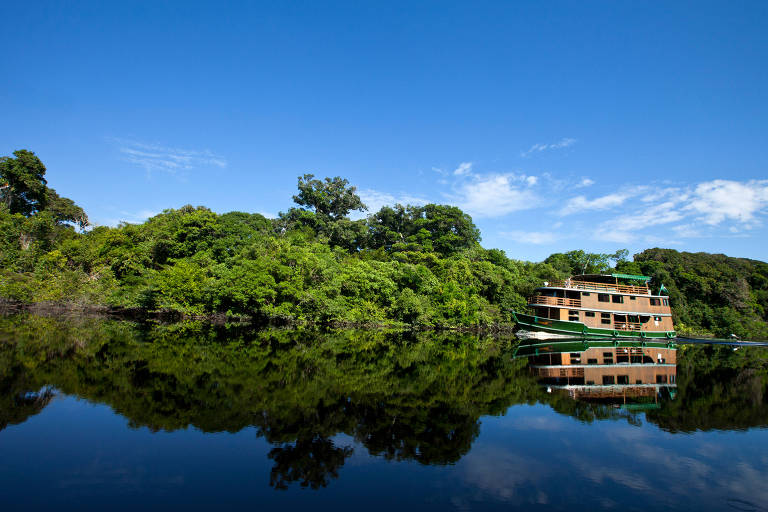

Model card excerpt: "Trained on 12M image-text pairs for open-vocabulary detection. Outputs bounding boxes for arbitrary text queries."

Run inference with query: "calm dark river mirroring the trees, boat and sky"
[0,315,768,511]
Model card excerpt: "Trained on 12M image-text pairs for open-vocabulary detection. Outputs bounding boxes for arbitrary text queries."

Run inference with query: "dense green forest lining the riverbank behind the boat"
[0,150,768,339]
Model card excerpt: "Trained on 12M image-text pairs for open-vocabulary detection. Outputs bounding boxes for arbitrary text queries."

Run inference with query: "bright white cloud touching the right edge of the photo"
[686,180,768,226]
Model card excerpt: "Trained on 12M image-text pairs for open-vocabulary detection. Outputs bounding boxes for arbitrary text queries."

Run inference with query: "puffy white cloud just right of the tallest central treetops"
[456,174,539,217]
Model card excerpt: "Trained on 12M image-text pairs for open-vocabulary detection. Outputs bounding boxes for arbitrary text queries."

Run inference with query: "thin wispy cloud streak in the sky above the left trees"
[109,139,227,174]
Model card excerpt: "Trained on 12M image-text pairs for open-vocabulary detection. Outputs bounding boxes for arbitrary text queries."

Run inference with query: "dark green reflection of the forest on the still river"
[0,315,768,489]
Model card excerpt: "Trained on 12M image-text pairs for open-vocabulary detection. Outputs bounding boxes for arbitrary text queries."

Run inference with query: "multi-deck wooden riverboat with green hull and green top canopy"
[513,273,676,339]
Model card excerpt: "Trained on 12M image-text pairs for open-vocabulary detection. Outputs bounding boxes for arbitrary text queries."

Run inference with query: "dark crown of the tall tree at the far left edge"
[0,149,48,217]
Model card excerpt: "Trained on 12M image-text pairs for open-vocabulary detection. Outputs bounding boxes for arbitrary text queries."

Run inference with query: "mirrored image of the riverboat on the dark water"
[515,339,677,409]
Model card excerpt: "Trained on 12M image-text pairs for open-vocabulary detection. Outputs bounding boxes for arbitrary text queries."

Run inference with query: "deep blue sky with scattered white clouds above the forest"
[0,1,768,260]
